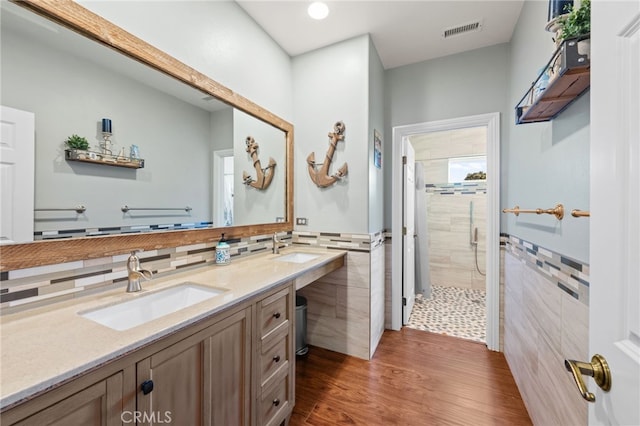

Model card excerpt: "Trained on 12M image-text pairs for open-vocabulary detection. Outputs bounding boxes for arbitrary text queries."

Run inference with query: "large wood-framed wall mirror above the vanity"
[1,1,293,271]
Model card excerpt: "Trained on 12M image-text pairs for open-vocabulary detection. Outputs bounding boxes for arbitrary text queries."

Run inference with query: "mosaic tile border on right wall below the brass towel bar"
[500,234,589,306]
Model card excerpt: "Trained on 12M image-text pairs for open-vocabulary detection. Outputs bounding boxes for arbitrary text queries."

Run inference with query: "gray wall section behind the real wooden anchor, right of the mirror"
[293,35,371,233]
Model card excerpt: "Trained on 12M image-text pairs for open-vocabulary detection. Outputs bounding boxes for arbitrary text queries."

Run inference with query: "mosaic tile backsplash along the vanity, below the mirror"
[0,233,292,315]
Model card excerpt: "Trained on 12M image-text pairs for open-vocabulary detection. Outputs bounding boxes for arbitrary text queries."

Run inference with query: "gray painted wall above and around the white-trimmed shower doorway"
[384,44,513,233]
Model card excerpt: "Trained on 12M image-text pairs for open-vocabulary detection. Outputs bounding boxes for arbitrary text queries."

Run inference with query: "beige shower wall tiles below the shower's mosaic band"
[426,192,487,290]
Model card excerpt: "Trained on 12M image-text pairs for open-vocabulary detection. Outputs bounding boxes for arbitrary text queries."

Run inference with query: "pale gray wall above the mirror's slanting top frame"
[80,0,293,121]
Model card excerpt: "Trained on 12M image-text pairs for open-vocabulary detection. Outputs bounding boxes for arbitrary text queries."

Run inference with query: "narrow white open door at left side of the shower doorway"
[402,138,416,324]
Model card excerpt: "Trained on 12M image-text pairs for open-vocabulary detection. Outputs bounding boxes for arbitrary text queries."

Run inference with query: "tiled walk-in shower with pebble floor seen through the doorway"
[408,127,487,342]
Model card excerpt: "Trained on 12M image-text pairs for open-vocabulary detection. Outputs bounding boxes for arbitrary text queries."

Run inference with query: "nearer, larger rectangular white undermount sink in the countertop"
[79,283,227,331]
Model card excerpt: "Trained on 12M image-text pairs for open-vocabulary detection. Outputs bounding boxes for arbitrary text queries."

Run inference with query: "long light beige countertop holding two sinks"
[0,247,346,410]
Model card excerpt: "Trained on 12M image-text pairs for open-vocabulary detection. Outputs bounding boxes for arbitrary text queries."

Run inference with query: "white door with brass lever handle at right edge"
[582,0,640,425]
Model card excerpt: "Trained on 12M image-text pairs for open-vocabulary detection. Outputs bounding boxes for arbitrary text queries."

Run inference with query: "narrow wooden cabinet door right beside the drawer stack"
[207,308,252,426]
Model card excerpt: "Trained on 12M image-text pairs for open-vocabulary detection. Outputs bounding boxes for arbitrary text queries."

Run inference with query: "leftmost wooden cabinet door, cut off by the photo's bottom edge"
[15,372,123,426]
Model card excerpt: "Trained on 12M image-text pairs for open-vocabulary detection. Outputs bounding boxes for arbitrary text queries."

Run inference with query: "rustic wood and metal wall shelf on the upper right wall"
[516,34,591,124]
